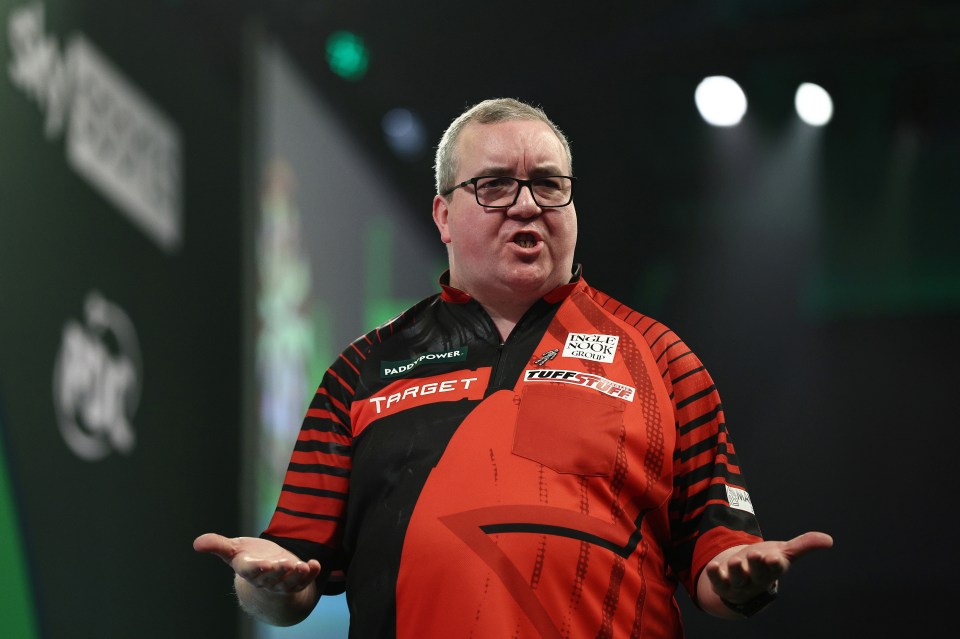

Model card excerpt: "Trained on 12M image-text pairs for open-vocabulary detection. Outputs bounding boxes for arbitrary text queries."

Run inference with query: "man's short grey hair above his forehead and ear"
[433,98,573,193]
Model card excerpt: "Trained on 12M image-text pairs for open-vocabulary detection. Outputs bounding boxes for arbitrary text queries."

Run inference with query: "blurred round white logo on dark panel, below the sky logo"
[53,291,143,462]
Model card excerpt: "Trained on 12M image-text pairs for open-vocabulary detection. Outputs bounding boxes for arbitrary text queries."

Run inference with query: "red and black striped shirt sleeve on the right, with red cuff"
[593,289,760,597]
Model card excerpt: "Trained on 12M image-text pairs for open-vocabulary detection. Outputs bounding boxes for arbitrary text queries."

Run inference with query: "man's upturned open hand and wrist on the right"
[697,532,833,619]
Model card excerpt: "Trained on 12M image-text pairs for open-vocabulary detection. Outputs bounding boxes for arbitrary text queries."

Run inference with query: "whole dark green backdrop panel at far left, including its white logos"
[0,0,241,638]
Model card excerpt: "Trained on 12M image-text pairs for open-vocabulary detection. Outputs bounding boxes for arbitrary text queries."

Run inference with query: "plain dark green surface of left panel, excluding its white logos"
[0,0,242,637]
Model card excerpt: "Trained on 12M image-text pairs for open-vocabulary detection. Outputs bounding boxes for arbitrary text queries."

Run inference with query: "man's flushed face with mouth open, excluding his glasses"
[433,120,577,304]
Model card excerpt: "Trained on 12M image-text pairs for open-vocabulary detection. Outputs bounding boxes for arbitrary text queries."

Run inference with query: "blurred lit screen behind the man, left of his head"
[248,37,445,639]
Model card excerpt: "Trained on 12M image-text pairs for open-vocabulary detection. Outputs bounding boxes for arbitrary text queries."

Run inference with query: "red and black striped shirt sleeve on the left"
[260,338,365,595]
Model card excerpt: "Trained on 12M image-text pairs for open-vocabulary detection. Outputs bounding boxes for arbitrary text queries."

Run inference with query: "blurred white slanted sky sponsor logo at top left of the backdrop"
[7,2,183,251]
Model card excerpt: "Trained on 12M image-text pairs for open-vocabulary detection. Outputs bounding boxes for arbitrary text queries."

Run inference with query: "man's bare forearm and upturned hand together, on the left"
[193,533,320,626]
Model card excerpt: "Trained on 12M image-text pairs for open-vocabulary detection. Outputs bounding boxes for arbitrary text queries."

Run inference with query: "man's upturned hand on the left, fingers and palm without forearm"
[193,533,320,594]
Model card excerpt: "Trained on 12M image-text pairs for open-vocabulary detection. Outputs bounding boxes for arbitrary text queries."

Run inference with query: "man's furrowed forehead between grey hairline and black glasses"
[458,120,569,173]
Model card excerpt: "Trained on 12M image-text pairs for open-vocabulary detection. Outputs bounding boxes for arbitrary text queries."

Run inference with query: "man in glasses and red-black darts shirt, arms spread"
[194,100,832,638]
